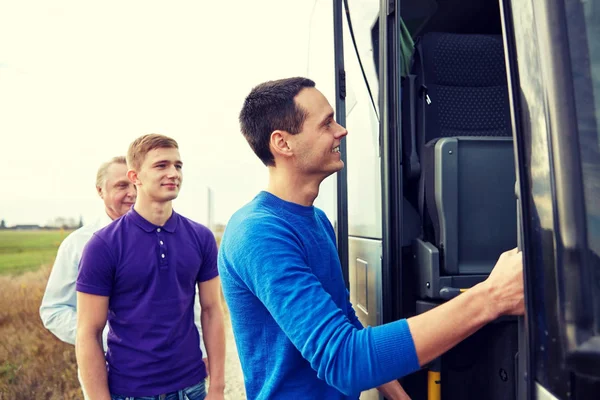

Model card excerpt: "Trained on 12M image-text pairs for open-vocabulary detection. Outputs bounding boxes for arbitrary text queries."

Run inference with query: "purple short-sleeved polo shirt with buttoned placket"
[77,208,218,396]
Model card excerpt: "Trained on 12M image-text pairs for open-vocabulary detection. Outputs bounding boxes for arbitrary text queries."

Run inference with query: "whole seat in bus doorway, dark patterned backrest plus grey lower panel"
[403,32,517,288]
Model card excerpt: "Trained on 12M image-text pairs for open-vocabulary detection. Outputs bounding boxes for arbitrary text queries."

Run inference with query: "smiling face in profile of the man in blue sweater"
[289,88,348,179]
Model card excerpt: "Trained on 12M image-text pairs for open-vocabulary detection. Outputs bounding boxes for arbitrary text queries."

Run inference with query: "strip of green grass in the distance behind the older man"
[0,230,70,275]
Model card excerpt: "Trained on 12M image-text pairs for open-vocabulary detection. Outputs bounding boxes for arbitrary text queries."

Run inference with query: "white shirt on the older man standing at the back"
[40,213,207,357]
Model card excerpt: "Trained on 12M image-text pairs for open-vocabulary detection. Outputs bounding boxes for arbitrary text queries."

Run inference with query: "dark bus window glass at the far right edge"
[565,0,600,324]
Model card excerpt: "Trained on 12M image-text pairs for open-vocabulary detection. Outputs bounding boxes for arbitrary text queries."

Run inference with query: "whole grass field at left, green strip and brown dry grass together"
[0,231,82,400]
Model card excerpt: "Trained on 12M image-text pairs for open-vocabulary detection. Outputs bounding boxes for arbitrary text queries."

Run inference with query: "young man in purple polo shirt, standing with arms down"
[76,134,225,400]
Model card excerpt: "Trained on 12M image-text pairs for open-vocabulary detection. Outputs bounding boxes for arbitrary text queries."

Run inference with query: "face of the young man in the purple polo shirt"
[136,147,183,202]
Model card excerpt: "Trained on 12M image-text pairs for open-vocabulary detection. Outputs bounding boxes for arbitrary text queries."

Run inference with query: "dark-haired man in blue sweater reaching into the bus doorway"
[218,78,524,400]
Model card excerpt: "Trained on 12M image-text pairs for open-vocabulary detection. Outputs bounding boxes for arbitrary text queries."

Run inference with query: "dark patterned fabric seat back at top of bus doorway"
[413,32,511,142]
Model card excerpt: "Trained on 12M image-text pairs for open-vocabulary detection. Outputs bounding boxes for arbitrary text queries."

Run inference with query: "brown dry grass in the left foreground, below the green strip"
[0,264,83,400]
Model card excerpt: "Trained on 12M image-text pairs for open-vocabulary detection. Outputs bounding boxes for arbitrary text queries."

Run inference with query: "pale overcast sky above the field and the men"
[0,0,333,225]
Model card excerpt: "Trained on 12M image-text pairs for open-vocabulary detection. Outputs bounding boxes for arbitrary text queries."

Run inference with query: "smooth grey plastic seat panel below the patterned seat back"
[424,136,517,275]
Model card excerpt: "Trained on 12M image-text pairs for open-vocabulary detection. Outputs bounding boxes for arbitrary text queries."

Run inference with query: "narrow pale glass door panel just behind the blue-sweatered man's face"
[330,0,384,400]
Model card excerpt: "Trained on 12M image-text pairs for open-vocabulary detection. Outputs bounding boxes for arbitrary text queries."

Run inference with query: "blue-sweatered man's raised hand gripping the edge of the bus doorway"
[483,248,525,319]
